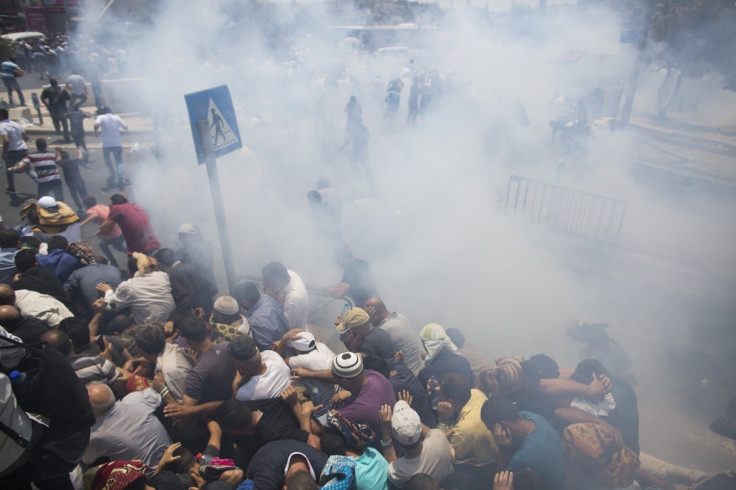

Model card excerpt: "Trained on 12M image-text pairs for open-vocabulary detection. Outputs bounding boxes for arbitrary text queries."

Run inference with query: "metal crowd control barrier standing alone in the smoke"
[505,175,626,244]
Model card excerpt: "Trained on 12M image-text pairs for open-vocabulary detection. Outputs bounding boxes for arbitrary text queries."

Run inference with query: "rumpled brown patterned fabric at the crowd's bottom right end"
[562,422,639,488]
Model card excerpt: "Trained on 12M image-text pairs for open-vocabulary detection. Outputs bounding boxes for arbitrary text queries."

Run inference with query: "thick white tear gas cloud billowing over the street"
[79,1,736,470]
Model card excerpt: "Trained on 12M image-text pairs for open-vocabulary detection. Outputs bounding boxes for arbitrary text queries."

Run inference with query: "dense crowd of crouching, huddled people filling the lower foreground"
[0,184,733,490]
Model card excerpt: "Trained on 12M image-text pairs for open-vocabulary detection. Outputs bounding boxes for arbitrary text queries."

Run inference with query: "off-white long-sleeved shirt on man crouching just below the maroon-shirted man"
[105,271,176,325]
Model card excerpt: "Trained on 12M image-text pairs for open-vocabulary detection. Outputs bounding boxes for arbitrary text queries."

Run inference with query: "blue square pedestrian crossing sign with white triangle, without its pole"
[184,85,243,163]
